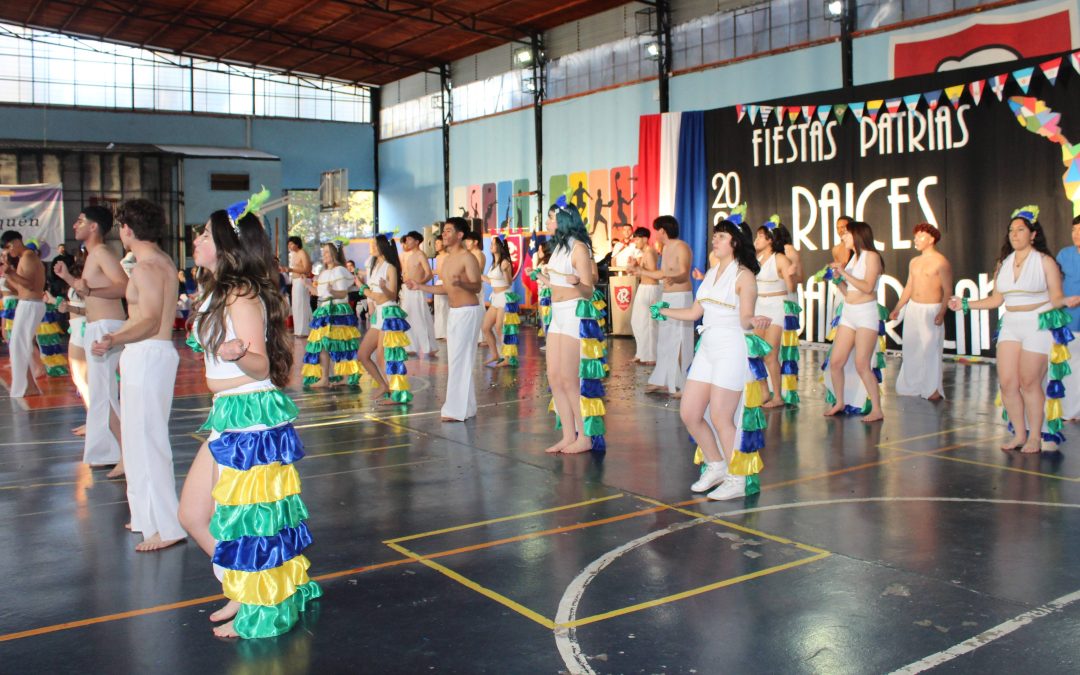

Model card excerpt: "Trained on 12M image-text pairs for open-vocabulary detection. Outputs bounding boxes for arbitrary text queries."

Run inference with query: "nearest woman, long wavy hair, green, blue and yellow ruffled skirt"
[180,202,322,637]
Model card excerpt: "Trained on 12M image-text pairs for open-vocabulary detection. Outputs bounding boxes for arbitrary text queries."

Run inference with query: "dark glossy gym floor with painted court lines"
[0,330,1080,675]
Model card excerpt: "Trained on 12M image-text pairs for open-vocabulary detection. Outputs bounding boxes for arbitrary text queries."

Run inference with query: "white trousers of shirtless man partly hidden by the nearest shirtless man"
[82,319,124,465]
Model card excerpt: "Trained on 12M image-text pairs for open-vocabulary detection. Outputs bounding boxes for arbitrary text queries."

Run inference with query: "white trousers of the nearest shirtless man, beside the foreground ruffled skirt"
[120,340,187,541]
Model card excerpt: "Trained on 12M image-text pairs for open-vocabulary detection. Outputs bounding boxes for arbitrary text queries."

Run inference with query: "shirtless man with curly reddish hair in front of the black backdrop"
[889,222,953,401]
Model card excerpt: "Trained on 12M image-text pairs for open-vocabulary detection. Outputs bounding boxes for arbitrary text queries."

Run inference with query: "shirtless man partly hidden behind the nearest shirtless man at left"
[53,206,127,478]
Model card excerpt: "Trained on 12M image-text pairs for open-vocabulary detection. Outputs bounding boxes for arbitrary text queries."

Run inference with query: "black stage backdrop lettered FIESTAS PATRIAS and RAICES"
[705,55,1080,355]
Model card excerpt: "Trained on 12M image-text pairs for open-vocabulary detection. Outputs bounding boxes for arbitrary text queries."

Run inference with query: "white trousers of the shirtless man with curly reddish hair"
[896,302,945,399]
